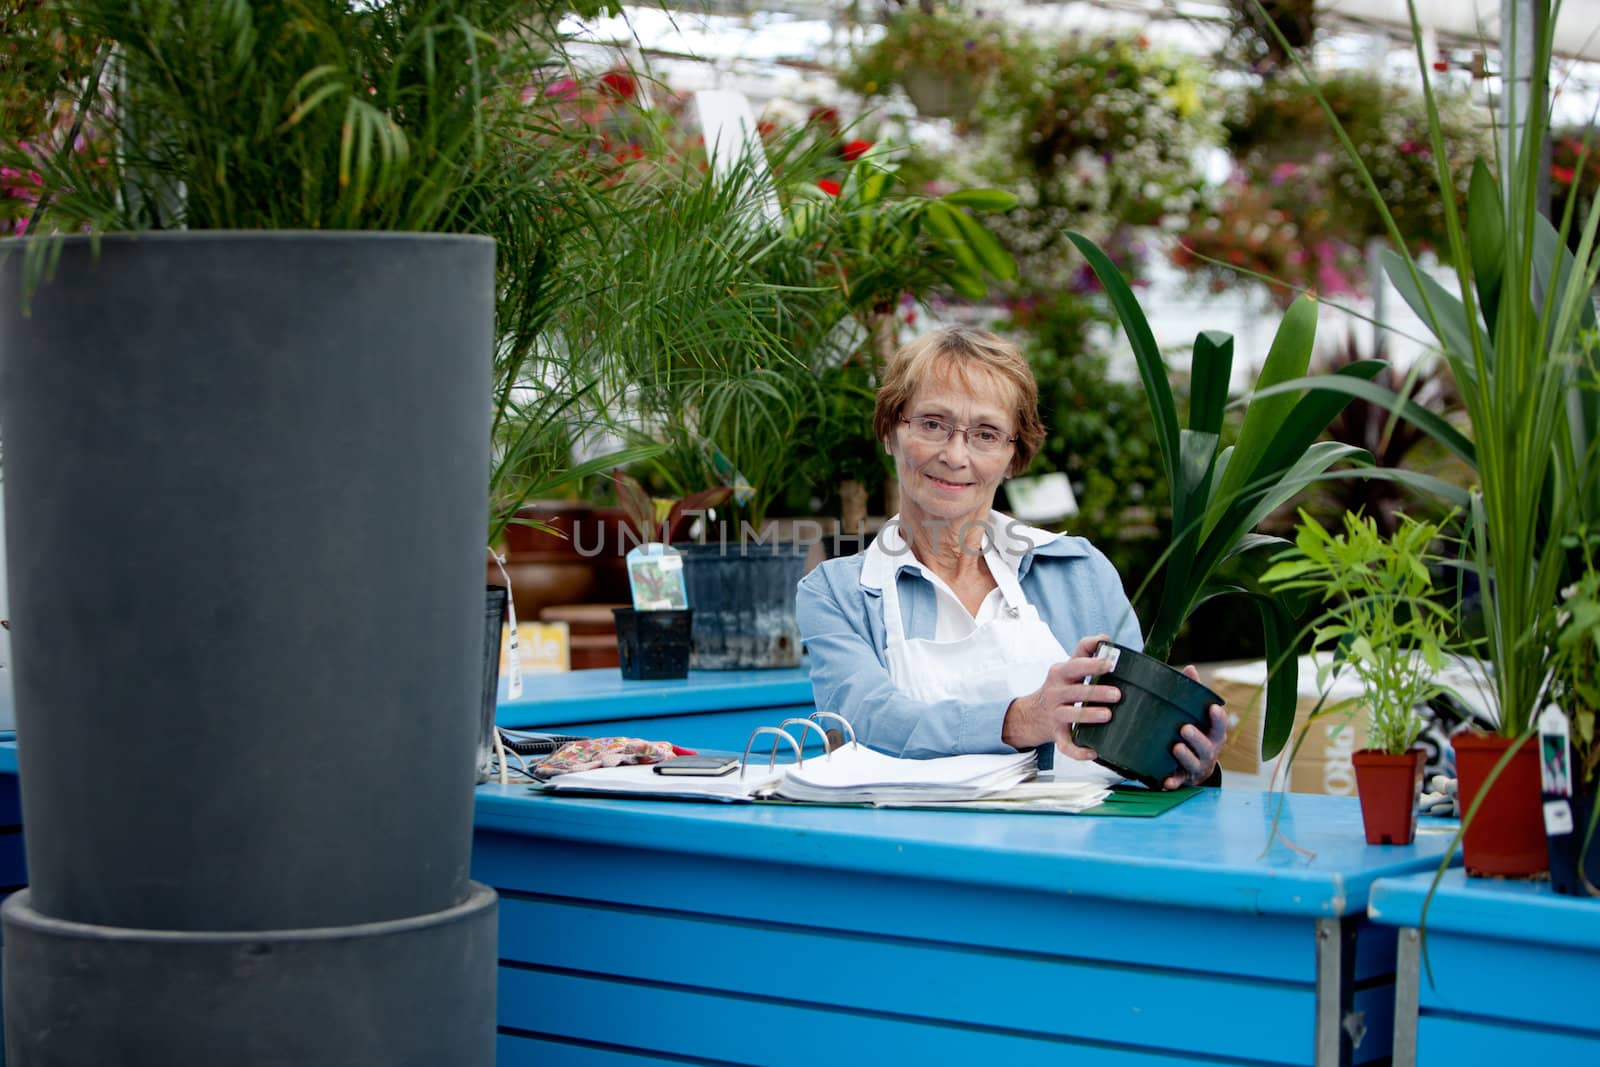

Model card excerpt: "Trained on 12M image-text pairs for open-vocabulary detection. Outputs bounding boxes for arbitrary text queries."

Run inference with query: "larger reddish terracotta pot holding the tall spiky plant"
[1451,734,1549,878]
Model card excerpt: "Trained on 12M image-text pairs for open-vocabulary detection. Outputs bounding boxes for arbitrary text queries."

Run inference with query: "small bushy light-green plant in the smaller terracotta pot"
[1261,510,1454,845]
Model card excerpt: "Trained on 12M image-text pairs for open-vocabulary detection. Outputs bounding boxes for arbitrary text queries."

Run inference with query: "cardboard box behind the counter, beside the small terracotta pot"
[1200,657,1366,797]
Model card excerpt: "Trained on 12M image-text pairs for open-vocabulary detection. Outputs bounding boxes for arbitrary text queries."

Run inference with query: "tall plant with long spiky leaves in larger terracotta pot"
[1248,0,1600,877]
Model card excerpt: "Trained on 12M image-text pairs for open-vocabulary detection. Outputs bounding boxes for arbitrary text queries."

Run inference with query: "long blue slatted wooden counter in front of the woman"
[474,785,1445,1064]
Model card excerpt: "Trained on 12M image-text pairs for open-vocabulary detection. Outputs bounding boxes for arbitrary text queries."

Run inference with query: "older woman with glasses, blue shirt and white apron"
[798,326,1227,789]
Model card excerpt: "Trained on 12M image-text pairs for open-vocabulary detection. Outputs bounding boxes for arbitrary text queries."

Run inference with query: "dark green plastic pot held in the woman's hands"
[1072,643,1222,789]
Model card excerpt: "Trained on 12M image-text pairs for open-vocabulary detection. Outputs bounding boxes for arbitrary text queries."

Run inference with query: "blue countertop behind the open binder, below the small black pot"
[494,665,811,726]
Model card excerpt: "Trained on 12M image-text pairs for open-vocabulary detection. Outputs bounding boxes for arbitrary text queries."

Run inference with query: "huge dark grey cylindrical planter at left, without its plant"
[0,232,494,1065]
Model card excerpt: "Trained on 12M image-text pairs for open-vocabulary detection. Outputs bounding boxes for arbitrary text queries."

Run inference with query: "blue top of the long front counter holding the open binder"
[477,784,1454,917]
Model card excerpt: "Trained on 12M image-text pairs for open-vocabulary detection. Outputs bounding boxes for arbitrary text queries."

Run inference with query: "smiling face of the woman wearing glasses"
[888,374,1016,522]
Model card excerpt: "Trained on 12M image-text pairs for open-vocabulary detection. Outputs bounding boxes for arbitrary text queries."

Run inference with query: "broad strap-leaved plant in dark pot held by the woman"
[1067,234,1384,782]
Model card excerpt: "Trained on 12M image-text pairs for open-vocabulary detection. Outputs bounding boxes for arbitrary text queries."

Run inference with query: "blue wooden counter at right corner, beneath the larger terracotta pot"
[1370,870,1600,1067]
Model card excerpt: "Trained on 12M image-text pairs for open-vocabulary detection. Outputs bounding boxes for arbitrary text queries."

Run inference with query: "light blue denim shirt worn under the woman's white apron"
[797,517,1144,766]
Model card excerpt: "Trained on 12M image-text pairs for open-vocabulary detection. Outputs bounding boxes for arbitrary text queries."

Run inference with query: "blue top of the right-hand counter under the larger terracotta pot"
[1368,867,1600,950]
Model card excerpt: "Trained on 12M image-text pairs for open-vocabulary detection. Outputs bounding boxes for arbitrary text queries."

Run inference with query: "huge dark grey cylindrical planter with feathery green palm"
[0,0,595,1064]
